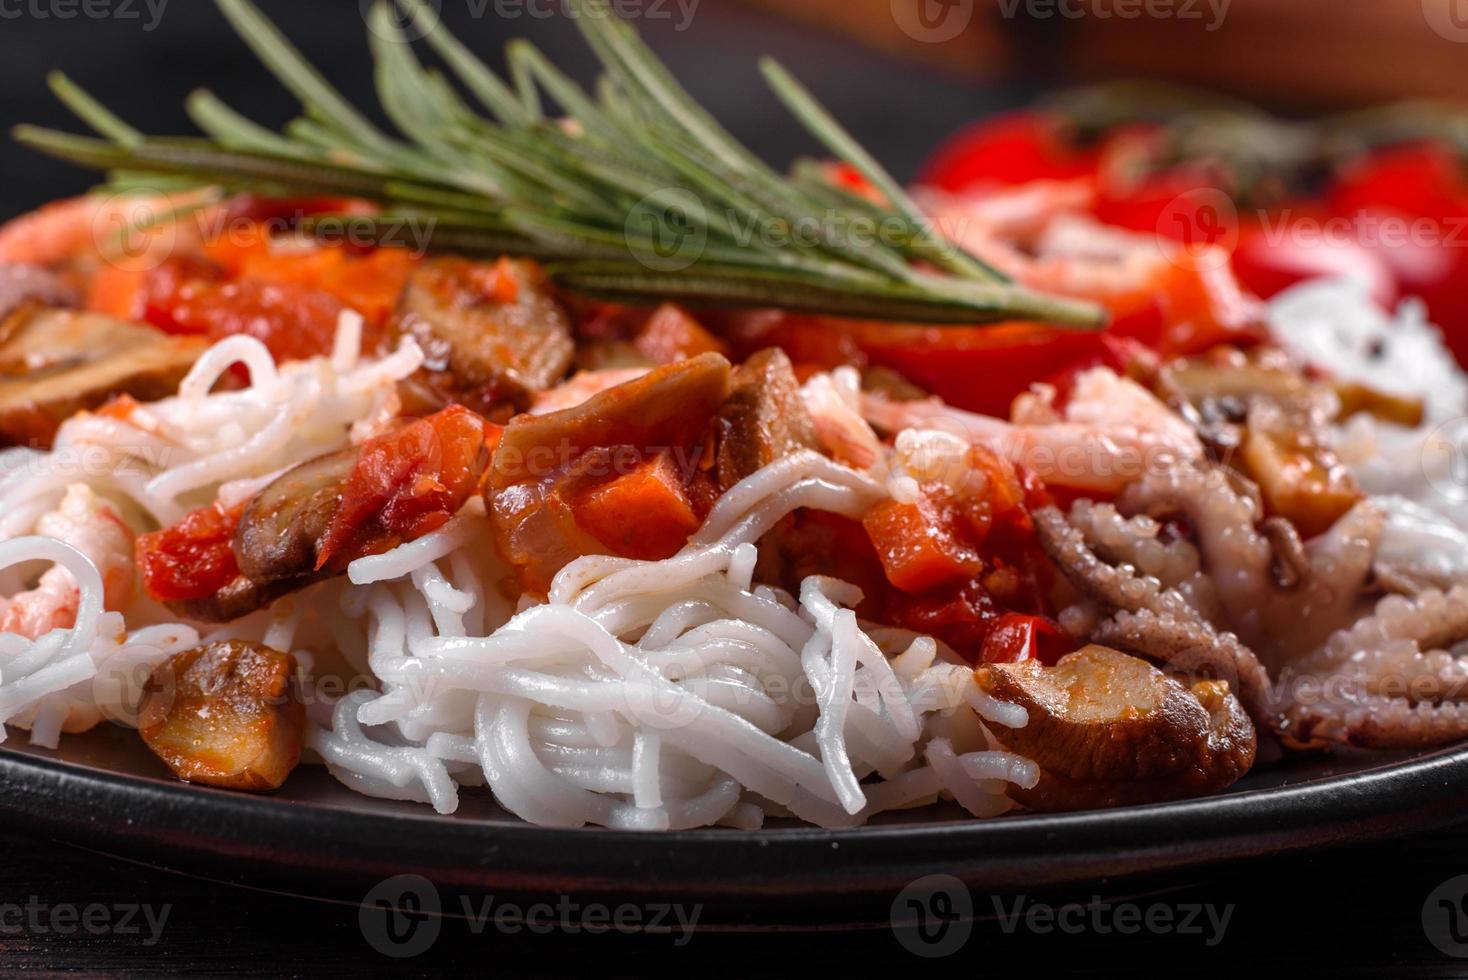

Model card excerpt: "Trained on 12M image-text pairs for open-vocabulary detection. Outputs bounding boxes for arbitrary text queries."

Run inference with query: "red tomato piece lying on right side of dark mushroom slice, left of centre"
[317,405,502,571]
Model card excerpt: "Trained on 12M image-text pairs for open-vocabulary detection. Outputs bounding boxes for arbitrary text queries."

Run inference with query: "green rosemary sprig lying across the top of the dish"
[15,0,1104,327]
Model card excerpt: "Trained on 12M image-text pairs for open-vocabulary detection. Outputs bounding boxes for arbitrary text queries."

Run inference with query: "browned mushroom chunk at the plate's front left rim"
[138,640,305,792]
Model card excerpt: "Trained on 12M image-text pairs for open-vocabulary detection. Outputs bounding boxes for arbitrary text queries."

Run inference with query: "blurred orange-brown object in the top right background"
[749,0,1468,109]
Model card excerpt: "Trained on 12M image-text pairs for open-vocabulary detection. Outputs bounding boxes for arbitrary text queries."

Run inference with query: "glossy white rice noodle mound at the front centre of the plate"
[311,453,1028,829]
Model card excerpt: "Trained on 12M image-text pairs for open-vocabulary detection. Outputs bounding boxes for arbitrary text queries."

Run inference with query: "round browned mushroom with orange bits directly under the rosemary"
[395,257,575,417]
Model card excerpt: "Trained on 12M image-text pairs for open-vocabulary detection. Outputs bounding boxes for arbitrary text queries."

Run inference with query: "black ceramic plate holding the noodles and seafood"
[0,728,1468,924]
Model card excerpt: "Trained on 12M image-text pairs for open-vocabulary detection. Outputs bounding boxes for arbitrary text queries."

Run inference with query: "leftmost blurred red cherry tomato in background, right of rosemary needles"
[919,113,1101,191]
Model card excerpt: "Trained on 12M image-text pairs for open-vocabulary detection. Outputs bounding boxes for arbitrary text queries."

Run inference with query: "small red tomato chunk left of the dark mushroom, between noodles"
[135,503,244,603]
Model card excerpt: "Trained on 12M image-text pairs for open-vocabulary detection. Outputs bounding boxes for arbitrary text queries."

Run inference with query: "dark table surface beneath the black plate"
[0,827,1468,979]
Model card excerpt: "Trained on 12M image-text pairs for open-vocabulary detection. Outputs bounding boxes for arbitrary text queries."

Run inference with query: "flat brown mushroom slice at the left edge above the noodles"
[0,305,208,447]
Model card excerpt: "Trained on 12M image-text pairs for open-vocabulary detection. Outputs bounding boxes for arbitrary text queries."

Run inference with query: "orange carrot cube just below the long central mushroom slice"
[575,452,699,560]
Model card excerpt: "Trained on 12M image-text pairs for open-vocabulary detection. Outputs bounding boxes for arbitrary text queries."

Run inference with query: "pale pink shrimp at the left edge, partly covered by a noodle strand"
[0,483,135,640]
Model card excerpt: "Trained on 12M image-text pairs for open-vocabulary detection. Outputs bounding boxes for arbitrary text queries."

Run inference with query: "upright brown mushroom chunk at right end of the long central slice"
[718,348,819,490]
